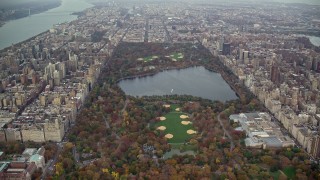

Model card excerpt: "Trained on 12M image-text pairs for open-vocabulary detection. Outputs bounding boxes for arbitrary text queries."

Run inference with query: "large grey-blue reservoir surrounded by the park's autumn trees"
[118,66,238,102]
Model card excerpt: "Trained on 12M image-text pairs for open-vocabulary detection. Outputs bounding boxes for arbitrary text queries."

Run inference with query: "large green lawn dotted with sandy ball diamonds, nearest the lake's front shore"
[156,106,194,143]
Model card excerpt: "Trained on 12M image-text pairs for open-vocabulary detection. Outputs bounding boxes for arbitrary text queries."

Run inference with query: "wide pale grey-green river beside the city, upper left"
[0,0,93,49]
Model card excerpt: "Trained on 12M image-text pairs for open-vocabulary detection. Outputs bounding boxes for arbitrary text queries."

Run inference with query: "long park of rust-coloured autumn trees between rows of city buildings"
[50,43,319,179]
